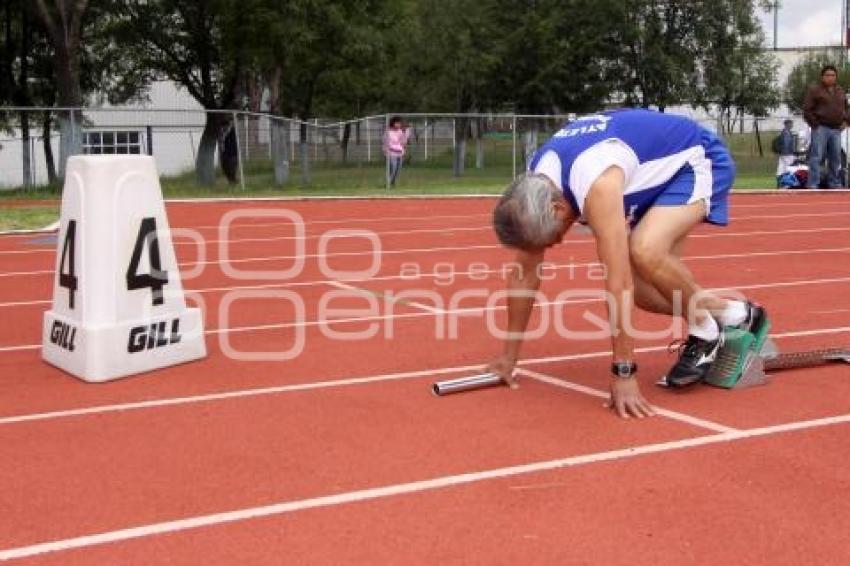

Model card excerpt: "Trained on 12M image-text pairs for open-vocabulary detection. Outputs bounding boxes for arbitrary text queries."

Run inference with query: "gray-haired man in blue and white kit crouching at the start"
[489,110,767,418]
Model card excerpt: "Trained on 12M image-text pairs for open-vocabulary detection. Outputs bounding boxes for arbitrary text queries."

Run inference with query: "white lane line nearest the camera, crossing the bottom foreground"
[0,414,850,560]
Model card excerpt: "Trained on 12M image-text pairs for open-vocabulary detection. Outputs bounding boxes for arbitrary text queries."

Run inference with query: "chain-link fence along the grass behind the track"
[0,108,846,193]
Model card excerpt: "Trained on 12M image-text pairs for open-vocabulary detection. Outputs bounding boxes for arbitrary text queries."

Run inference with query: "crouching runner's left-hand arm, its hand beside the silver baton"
[489,250,543,387]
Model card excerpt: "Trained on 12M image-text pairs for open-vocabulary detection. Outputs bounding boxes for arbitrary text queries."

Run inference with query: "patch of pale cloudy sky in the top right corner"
[757,0,844,47]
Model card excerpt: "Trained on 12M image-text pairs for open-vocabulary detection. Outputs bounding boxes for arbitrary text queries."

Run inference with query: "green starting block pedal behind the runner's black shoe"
[705,320,777,389]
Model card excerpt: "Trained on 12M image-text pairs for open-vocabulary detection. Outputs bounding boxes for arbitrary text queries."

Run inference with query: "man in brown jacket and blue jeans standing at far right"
[803,65,850,189]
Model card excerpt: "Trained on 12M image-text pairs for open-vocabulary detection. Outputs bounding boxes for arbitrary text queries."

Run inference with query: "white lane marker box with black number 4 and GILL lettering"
[42,155,206,382]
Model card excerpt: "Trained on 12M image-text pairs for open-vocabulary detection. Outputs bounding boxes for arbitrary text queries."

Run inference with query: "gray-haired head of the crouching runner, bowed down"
[493,173,563,249]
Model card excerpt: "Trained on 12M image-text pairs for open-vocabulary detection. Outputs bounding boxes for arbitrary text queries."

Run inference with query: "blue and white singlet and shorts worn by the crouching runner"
[529,109,735,225]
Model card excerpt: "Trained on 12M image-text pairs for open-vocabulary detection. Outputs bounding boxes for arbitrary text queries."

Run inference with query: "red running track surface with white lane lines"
[0,193,850,565]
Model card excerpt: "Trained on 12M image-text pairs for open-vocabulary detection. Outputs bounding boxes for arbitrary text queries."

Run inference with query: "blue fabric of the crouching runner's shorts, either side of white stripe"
[631,130,735,226]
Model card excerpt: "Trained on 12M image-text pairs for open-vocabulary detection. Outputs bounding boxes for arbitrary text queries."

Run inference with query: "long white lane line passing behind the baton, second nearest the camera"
[0,326,850,426]
